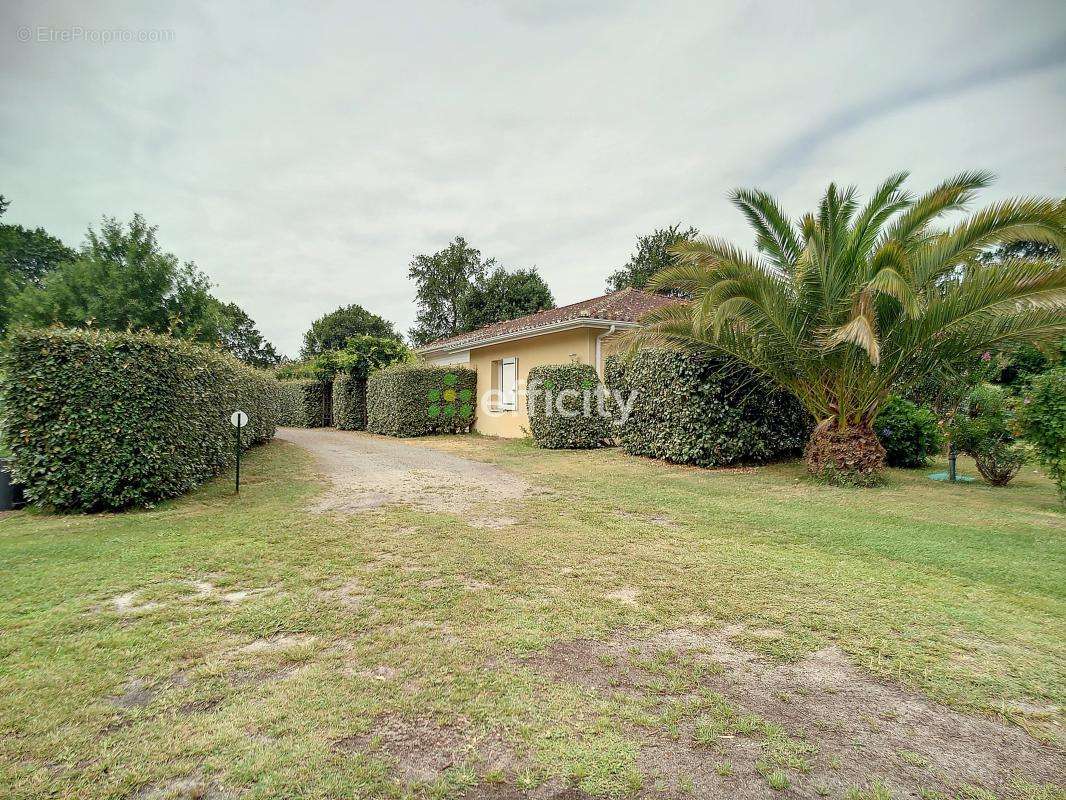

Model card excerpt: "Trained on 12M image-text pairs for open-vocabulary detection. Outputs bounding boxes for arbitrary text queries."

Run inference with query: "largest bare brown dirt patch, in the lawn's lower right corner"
[526,627,1066,799]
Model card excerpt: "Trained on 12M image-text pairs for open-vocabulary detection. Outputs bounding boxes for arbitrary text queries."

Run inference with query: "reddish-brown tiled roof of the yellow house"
[418,289,677,351]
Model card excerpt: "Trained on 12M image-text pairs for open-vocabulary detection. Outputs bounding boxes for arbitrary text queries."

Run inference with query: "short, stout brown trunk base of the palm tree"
[804,417,885,486]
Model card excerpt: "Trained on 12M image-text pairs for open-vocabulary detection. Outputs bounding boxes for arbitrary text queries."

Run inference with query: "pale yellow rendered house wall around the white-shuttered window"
[469,327,603,438]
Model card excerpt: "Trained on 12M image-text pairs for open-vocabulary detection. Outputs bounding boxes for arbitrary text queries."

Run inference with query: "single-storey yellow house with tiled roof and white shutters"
[417,289,674,437]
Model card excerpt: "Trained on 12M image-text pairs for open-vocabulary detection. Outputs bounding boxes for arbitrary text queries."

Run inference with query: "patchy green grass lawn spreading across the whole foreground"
[0,437,1066,800]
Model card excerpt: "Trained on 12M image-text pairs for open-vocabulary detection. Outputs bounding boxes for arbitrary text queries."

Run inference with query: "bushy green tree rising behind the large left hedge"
[12,214,220,343]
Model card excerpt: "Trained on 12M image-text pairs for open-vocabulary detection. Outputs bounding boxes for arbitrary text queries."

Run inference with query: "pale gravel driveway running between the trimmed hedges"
[277,428,530,520]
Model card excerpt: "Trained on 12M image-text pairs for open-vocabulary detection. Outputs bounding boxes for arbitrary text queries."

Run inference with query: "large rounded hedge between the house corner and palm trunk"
[605,350,812,467]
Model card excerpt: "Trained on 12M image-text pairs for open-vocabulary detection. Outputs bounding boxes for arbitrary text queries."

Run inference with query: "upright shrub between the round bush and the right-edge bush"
[949,386,1025,486]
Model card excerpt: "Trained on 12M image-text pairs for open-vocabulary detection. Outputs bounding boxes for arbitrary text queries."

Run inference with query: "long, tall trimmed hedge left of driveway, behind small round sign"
[3,330,281,511]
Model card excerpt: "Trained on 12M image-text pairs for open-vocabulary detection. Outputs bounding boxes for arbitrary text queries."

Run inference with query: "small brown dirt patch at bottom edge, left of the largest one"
[334,715,518,784]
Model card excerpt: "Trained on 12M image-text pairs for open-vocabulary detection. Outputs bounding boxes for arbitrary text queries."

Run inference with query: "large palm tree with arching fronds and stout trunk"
[637,172,1066,482]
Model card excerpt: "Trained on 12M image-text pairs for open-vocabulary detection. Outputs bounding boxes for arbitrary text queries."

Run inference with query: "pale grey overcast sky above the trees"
[0,0,1066,354]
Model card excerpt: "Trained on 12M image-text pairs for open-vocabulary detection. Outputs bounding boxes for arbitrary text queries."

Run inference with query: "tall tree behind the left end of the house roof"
[407,236,496,347]
